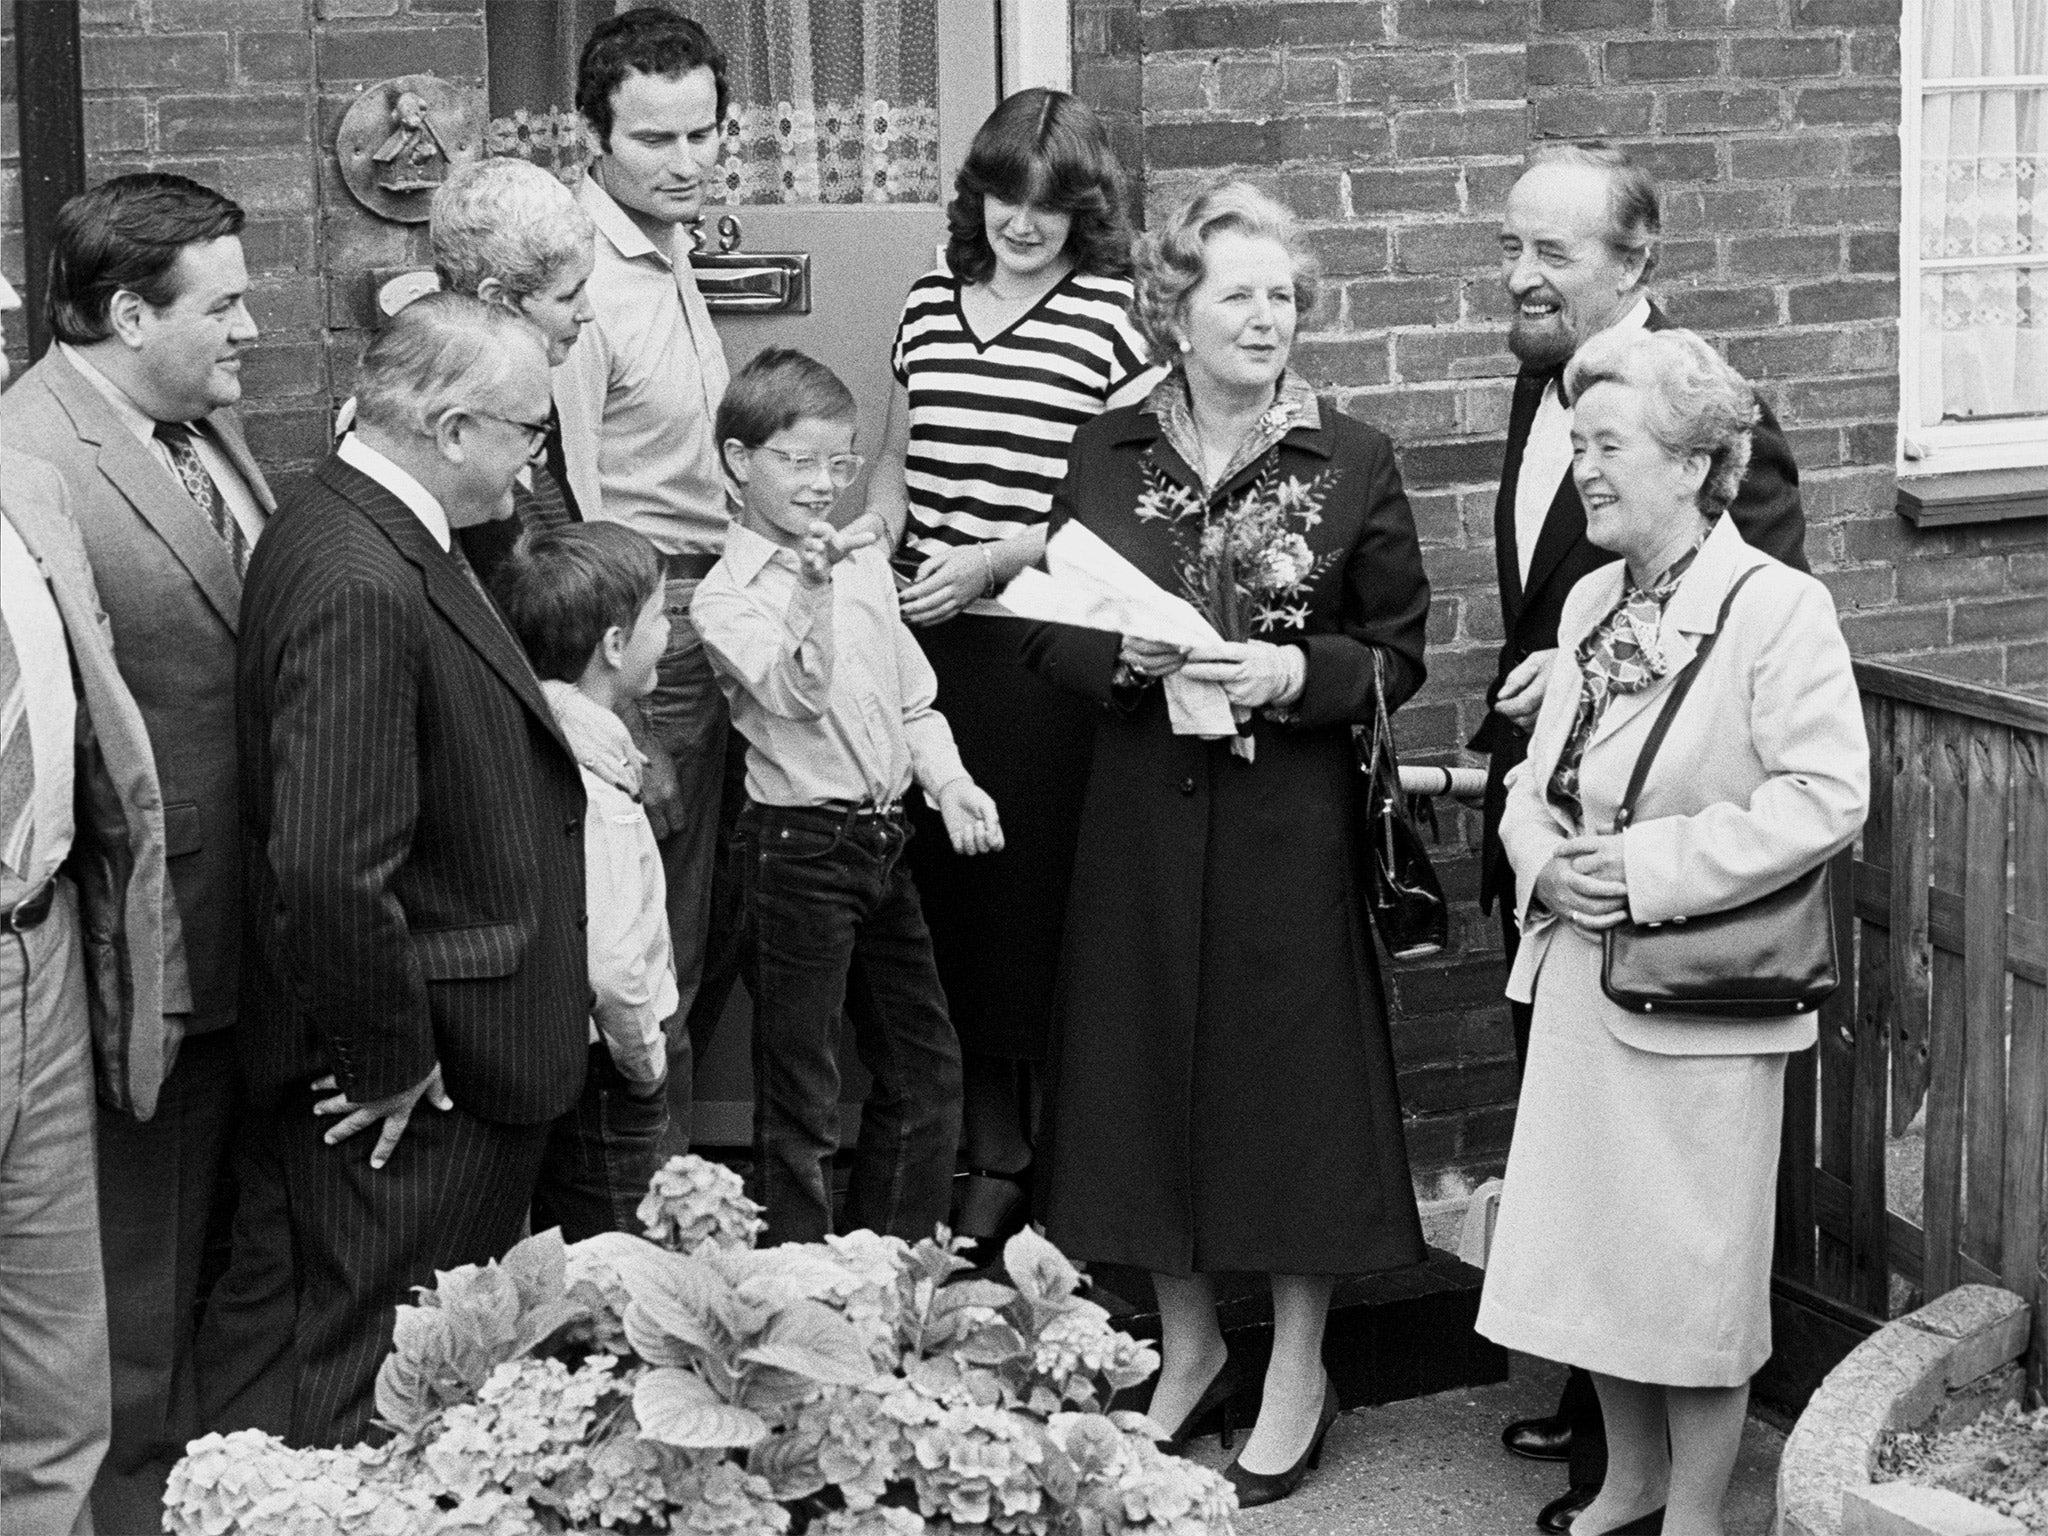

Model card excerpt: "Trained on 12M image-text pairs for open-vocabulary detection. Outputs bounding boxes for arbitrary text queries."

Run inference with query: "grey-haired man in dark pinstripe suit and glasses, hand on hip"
[238,293,590,1446]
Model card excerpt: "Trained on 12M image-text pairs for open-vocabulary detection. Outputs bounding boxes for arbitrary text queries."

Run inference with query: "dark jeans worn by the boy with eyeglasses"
[733,801,961,1243]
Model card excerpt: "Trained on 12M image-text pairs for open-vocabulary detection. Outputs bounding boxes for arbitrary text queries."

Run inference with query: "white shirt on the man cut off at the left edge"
[0,516,78,907]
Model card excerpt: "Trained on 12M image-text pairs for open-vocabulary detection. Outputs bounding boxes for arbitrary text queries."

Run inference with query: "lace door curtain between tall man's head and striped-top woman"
[686,0,940,203]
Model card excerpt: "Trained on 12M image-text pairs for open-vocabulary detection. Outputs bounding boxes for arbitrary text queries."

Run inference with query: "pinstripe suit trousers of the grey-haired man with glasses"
[276,1090,551,1446]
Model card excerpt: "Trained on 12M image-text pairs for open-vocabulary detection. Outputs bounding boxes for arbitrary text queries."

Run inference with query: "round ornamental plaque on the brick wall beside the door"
[334,74,485,223]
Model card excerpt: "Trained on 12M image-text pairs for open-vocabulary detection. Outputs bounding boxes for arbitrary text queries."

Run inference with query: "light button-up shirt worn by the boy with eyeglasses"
[690,522,967,805]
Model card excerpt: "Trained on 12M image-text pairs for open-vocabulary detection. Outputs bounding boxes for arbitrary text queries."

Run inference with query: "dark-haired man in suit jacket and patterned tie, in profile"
[0,172,291,1530]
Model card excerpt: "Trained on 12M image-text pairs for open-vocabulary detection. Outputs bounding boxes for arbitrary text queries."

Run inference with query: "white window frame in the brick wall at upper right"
[1896,0,2048,475]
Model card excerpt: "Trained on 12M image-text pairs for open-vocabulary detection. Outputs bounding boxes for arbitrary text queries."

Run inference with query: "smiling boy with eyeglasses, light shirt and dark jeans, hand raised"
[690,348,1004,1243]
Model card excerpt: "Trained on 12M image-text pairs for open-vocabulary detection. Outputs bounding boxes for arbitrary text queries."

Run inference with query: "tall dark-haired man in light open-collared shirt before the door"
[555,6,735,1151]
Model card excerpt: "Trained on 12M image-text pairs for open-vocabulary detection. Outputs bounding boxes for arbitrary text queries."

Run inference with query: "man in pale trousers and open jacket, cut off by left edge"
[0,268,176,1536]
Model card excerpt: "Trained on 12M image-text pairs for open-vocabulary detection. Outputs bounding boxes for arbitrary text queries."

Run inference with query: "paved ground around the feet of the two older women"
[1190,1354,1784,1536]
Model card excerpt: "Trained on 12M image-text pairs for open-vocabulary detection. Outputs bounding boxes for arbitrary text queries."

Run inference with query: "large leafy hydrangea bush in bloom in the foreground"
[164,1157,1237,1536]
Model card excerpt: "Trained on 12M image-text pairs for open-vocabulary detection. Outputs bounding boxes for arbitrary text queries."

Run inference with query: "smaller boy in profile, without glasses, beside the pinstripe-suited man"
[494,522,676,1243]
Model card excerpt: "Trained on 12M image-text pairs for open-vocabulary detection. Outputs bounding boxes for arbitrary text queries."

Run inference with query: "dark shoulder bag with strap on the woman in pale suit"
[1599,565,1841,1020]
